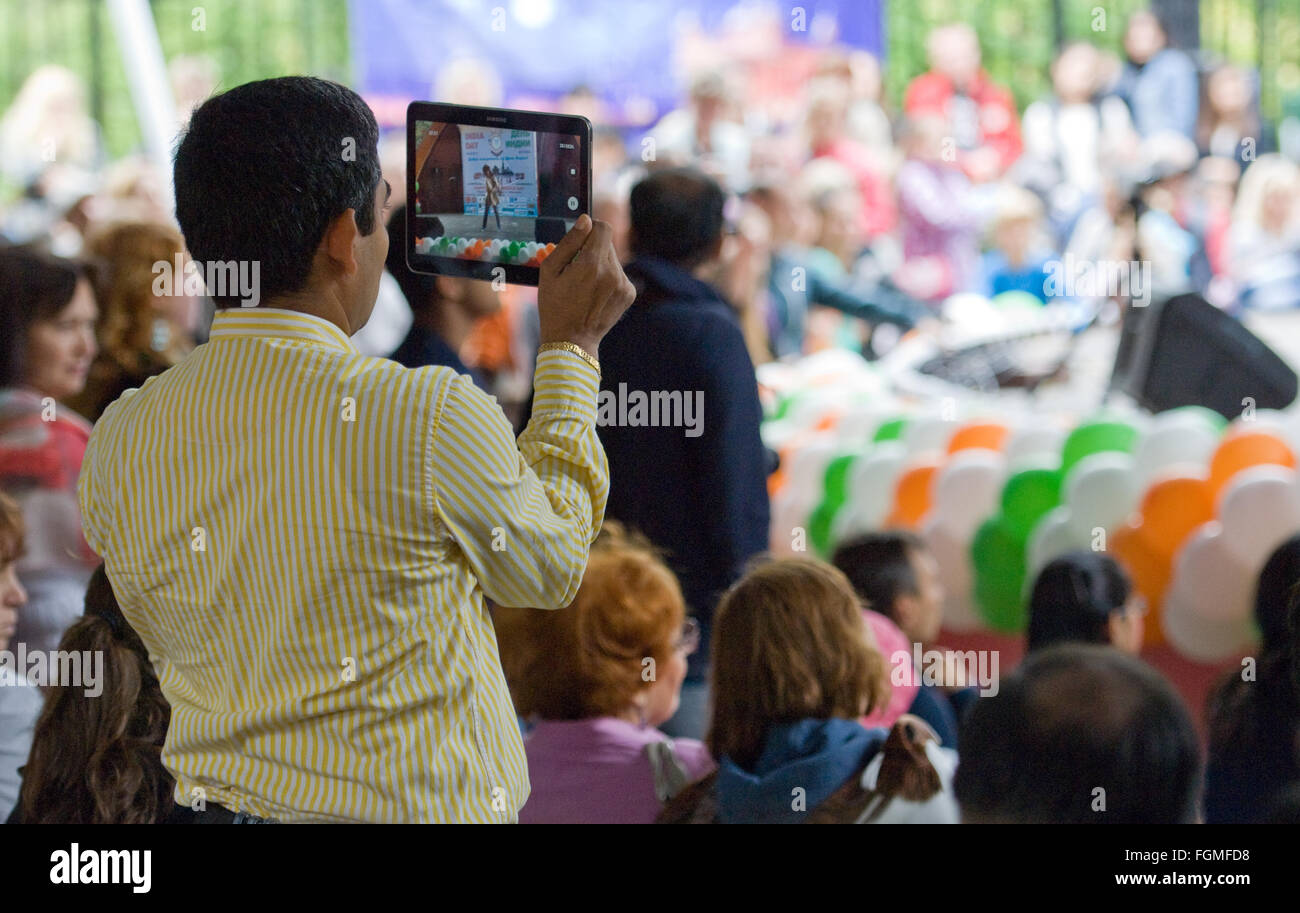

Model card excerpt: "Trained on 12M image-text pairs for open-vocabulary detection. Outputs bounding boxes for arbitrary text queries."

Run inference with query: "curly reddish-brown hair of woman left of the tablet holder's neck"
[86,221,185,367]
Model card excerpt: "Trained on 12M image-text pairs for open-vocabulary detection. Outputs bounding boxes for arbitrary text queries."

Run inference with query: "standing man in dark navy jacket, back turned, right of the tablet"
[597,169,768,737]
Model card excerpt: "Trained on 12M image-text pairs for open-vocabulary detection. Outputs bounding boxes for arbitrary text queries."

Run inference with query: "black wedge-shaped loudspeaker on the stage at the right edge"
[1110,294,1296,419]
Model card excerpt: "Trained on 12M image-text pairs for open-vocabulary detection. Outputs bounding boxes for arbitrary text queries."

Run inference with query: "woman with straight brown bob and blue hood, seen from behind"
[659,558,957,823]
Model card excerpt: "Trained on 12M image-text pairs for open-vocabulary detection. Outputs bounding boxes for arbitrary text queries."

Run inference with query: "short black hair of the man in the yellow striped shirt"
[174,77,381,307]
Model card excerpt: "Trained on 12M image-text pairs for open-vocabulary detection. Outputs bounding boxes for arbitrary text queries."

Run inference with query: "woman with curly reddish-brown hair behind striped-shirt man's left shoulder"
[68,221,199,423]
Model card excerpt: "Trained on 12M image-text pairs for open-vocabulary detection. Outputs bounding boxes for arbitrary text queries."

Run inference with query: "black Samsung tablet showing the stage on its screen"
[406,101,592,285]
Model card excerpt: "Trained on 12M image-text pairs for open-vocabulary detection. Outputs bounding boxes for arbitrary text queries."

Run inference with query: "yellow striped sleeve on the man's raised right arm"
[433,351,610,609]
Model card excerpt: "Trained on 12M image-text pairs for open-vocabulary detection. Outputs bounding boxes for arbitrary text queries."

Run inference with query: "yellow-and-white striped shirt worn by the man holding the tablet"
[78,308,608,822]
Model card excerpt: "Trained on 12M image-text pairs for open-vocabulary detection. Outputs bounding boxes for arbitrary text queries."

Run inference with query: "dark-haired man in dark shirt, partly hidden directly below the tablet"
[385,205,501,389]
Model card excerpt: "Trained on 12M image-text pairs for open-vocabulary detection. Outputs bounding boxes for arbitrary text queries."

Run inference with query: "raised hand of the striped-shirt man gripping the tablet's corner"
[537,213,636,358]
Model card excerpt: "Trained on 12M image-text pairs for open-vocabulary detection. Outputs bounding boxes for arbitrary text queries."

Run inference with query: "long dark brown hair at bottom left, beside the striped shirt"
[20,566,174,825]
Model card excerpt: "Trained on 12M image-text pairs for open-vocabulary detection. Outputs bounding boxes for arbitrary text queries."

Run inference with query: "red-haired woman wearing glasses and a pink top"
[497,522,714,823]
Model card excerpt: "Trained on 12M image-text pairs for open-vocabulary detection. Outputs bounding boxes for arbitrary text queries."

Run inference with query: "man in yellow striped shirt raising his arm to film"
[79,77,634,822]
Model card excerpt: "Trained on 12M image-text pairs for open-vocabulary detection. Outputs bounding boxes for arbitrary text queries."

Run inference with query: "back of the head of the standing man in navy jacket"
[629,168,727,269]
